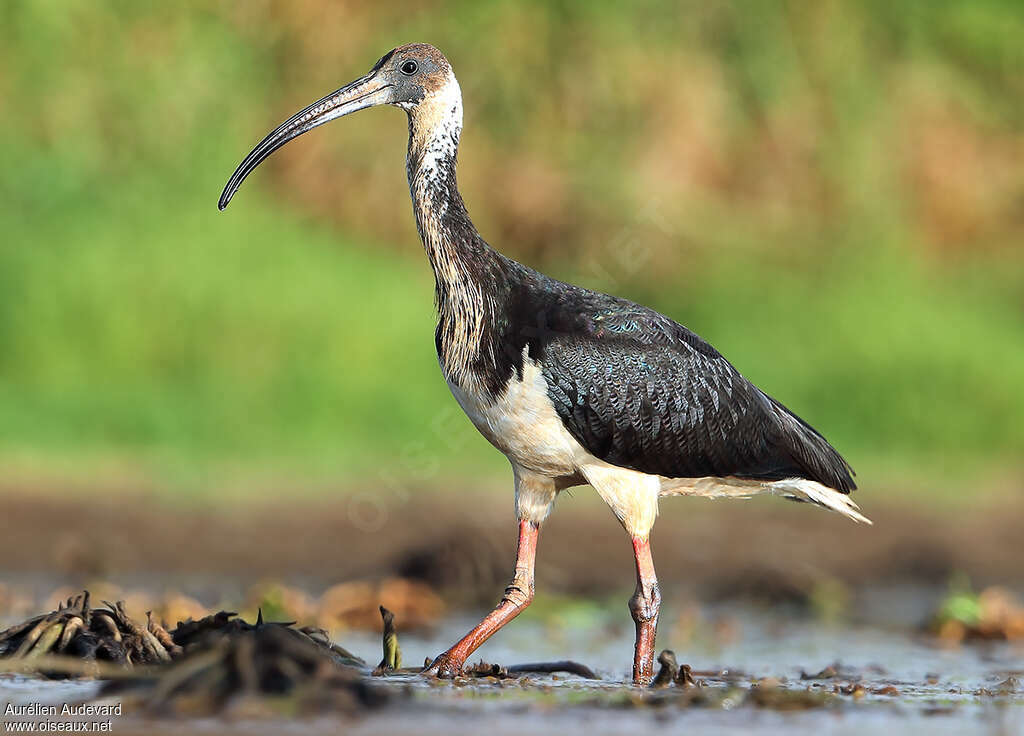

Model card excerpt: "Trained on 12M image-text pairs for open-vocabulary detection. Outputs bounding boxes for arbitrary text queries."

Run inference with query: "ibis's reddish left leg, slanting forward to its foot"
[423,520,541,678]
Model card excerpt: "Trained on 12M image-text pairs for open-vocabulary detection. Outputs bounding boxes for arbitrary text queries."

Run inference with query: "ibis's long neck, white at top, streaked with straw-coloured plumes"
[406,76,502,387]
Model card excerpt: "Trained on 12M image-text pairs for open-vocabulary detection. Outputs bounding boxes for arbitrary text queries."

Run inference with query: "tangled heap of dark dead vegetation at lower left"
[0,592,386,713]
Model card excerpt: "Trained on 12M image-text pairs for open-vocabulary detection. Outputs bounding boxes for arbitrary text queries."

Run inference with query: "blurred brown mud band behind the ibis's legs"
[0,487,1024,603]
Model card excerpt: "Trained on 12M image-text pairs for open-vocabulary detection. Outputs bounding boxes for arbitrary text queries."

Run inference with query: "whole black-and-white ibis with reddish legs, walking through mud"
[219,43,869,684]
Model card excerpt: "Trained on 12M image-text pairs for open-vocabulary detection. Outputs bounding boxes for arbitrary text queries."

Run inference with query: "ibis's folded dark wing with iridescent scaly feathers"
[542,305,854,490]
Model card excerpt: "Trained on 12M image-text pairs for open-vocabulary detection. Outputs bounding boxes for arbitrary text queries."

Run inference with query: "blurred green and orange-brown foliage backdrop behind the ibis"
[0,0,1024,497]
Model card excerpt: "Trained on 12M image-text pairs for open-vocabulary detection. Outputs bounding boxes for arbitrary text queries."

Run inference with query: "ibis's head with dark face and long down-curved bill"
[217,43,462,210]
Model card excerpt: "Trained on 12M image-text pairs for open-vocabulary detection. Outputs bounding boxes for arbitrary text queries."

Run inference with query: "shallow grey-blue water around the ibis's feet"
[0,605,1024,736]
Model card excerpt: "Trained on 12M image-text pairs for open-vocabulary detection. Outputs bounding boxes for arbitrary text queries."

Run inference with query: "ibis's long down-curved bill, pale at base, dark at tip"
[217,69,391,210]
